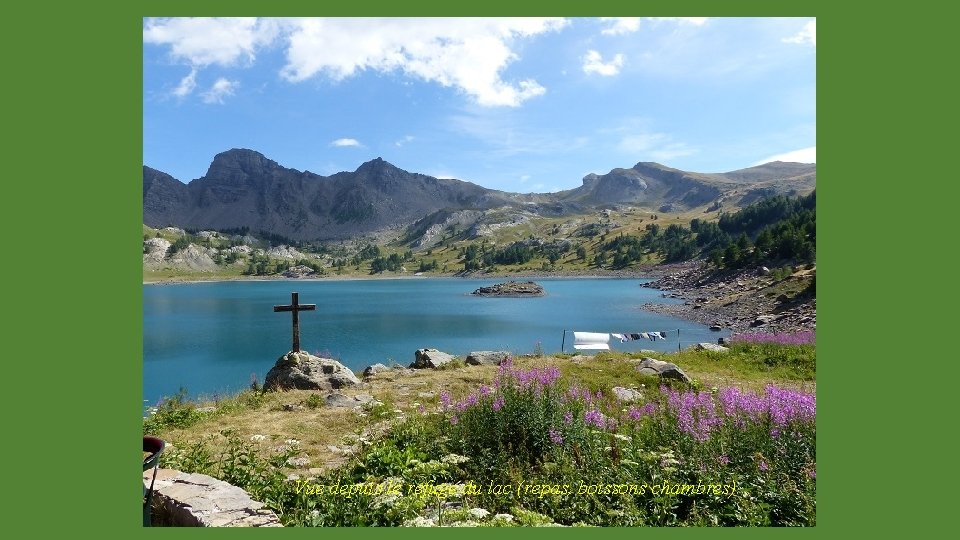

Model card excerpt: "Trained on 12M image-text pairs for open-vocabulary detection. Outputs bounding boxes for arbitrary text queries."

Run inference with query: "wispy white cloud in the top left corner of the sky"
[143,17,279,67]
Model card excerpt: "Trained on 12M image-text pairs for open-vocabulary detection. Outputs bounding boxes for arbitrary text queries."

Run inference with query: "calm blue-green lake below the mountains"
[143,278,729,404]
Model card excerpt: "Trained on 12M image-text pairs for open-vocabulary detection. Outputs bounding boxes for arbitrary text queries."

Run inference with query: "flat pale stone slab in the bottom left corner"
[143,469,283,527]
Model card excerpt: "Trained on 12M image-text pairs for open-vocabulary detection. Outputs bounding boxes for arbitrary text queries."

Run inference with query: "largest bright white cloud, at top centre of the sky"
[281,18,567,107]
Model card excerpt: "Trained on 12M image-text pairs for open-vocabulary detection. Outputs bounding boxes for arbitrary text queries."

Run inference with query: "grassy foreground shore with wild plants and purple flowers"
[144,344,816,526]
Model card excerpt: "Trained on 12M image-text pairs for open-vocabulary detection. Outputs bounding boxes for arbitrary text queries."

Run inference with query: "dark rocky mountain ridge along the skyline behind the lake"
[143,149,816,245]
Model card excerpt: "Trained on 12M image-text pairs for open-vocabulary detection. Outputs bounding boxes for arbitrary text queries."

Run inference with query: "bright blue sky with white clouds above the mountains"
[143,18,816,192]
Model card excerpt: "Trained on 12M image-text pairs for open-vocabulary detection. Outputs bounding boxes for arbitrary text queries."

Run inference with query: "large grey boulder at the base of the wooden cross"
[263,351,360,390]
